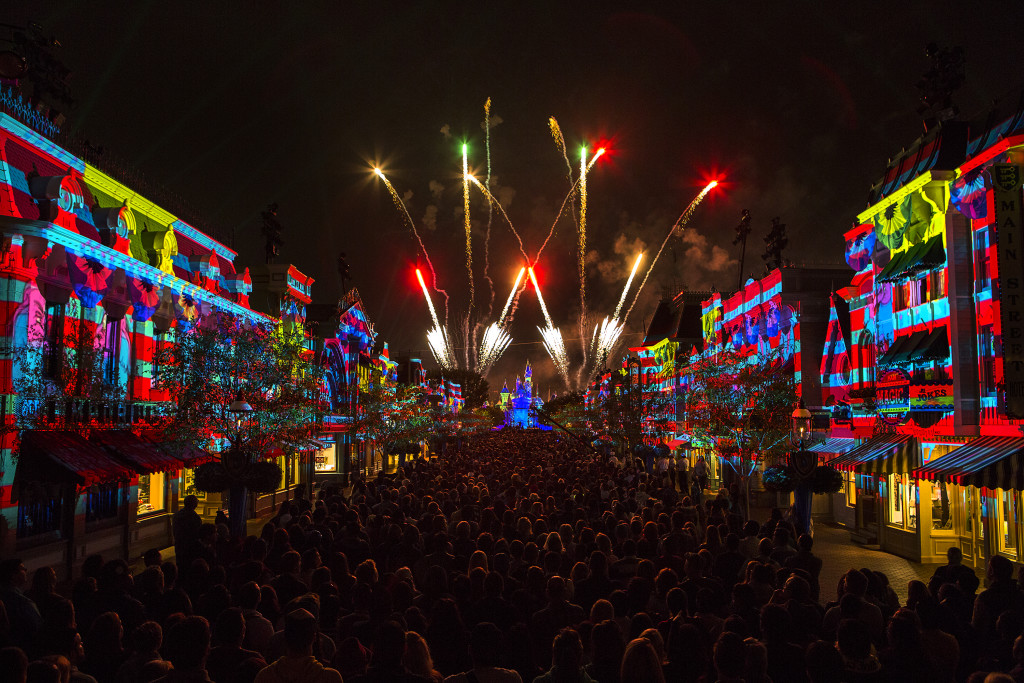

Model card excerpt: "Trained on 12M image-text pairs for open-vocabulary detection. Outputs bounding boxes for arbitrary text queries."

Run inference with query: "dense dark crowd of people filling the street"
[0,429,1024,683]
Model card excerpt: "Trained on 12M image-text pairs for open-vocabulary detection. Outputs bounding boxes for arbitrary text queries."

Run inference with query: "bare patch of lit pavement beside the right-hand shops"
[813,523,941,604]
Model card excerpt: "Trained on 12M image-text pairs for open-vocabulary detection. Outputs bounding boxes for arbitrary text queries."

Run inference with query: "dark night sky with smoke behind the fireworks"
[8,0,1024,390]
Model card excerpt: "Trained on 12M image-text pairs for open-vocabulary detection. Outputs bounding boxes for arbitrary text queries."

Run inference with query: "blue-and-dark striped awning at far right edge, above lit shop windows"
[913,436,1024,489]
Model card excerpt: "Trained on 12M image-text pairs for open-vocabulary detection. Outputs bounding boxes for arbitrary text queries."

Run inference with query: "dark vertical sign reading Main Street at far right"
[991,164,1024,419]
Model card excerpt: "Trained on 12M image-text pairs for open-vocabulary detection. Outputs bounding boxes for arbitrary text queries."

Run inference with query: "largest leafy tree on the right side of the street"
[684,350,797,507]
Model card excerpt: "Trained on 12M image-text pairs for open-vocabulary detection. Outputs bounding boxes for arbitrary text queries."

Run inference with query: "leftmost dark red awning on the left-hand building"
[15,430,132,486]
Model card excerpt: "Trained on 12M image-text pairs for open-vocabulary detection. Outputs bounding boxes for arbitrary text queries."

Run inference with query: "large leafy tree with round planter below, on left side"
[157,312,327,538]
